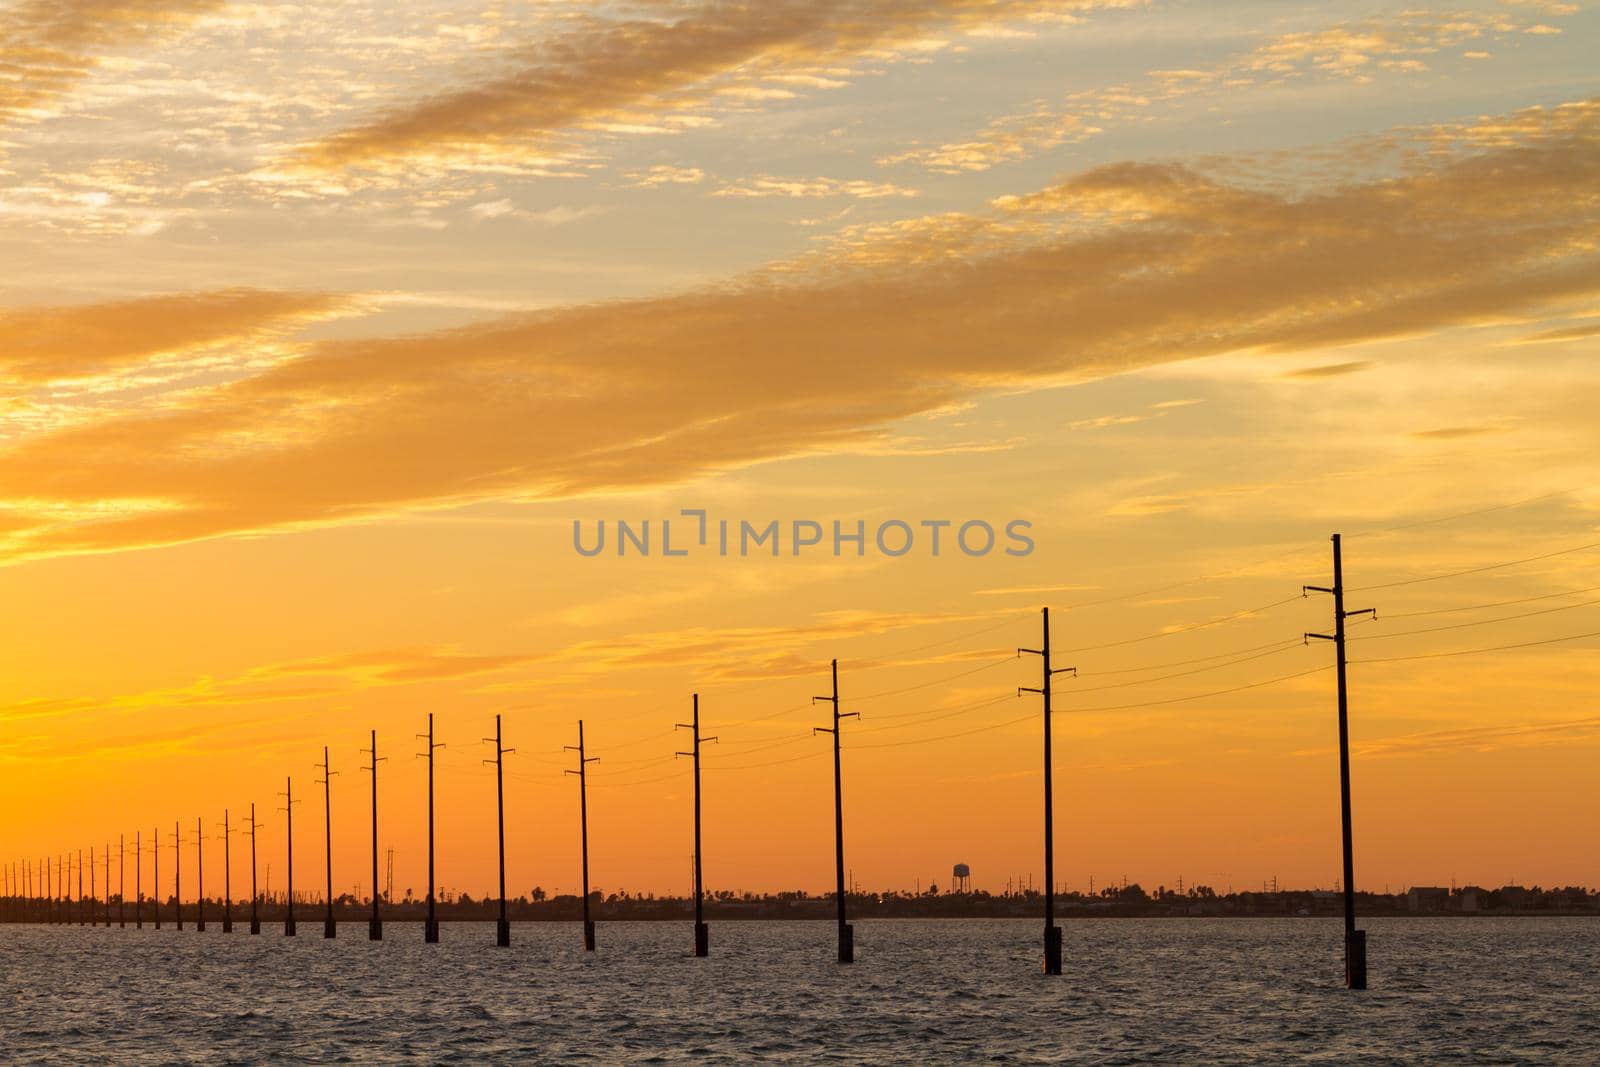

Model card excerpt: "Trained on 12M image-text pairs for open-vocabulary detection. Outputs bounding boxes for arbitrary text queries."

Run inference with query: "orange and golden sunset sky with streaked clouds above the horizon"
[0,0,1600,896]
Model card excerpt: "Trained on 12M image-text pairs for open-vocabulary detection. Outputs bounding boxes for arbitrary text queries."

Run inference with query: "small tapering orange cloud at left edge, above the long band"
[0,290,349,382]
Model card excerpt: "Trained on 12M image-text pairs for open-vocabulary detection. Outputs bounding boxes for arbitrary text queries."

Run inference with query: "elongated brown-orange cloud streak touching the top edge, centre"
[284,0,1126,170]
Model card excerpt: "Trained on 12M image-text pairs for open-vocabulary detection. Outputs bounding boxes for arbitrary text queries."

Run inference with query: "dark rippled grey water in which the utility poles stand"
[0,918,1600,1064]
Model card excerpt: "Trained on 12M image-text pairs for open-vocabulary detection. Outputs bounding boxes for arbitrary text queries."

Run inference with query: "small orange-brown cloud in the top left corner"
[0,0,226,125]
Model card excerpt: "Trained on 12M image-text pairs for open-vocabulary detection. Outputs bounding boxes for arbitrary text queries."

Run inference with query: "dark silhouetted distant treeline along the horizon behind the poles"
[0,885,1600,923]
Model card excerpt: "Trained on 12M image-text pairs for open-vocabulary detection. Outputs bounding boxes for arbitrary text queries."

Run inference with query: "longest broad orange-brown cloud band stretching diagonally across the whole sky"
[0,101,1600,560]
